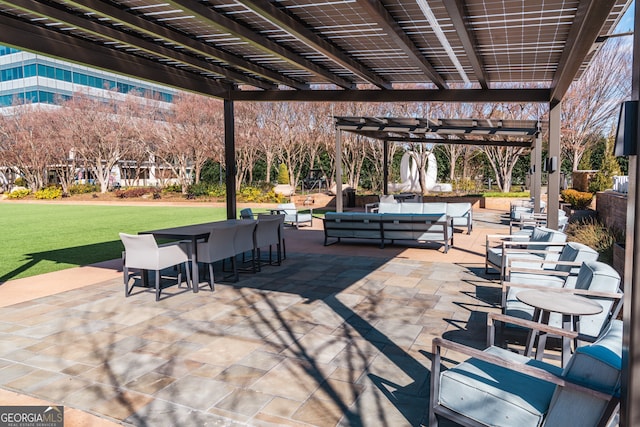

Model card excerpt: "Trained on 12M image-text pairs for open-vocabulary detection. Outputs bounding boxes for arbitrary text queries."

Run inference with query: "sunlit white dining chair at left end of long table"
[120,233,190,301]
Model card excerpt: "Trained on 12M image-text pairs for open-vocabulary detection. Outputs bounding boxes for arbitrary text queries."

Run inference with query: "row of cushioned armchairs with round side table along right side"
[429,222,623,426]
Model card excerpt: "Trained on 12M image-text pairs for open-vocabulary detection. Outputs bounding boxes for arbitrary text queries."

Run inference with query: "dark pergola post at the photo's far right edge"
[620,3,640,427]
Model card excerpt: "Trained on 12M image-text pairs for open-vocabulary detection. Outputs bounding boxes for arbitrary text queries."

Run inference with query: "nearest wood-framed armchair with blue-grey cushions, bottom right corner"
[429,320,622,427]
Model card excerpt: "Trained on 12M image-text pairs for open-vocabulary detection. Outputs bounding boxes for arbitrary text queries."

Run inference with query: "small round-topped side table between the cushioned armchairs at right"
[516,290,602,367]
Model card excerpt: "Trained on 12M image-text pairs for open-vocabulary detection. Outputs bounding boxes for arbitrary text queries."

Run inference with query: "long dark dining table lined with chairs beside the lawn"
[138,219,238,293]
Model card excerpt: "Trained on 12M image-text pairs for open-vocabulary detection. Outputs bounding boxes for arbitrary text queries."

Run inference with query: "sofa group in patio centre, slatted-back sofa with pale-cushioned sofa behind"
[324,202,473,253]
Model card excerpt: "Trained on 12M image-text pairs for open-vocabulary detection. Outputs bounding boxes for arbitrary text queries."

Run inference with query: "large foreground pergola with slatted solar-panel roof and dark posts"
[0,0,640,425]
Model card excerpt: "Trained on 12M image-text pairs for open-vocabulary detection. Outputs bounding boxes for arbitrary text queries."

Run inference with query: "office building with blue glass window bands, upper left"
[0,46,177,108]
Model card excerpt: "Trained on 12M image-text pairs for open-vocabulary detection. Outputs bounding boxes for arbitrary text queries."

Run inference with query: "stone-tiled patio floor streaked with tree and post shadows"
[0,207,520,426]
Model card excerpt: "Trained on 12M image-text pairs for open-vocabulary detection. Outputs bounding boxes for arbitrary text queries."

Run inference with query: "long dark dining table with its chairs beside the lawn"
[120,215,286,301]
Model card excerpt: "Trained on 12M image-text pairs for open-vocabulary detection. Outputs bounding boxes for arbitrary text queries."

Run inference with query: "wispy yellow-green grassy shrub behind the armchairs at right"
[565,218,624,264]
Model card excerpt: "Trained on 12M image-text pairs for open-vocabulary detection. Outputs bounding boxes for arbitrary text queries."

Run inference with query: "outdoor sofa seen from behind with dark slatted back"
[324,212,453,253]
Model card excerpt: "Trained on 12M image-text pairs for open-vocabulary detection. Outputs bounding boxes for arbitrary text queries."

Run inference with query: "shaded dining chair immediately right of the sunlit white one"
[197,224,238,290]
